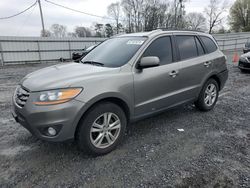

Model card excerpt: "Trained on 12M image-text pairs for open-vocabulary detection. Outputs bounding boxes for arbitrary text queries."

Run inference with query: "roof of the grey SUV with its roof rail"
[114,29,211,37]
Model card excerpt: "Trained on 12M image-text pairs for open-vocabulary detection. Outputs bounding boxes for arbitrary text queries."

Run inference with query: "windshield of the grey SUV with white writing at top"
[81,37,147,67]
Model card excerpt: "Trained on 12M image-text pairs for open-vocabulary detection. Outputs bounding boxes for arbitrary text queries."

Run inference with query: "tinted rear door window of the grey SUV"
[176,36,198,60]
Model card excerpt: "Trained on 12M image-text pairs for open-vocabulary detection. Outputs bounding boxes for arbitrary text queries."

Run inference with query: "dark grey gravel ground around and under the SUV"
[0,60,250,188]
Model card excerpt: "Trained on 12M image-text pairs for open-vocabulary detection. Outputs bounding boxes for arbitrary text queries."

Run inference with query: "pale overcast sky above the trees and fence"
[0,0,235,36]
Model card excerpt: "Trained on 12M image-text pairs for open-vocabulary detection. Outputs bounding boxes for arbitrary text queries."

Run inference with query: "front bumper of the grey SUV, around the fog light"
[12,95,84,142]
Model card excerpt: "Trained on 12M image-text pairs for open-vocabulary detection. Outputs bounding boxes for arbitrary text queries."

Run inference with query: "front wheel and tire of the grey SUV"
[76,102,127,155]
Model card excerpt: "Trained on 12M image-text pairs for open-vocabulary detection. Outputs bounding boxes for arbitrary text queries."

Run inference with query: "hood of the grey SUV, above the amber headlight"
[20,63,120,91]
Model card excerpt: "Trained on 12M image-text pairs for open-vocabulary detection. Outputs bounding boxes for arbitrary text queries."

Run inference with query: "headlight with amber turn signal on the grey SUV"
[33,88,82,105]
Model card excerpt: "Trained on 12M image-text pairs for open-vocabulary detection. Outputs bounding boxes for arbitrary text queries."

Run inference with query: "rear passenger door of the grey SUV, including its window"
[175,34,212,101]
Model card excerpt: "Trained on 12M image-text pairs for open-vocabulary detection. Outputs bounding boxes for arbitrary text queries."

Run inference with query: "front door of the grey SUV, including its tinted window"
[134,36,181,117]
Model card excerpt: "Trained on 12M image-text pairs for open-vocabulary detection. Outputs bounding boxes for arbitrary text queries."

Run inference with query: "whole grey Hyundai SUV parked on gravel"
[13,30,228,155]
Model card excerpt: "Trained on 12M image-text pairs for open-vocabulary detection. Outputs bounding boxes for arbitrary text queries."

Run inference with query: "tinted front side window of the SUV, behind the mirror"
[143,37,173,65]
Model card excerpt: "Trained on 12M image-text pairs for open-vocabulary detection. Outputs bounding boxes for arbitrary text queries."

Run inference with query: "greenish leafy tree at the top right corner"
[229,0,250,32]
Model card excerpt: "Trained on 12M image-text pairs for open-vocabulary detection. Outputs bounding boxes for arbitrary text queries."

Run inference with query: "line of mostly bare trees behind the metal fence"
[41,0,250,37]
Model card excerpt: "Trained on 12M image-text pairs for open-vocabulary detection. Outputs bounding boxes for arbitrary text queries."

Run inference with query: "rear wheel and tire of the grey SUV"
[194,78,219,111]
